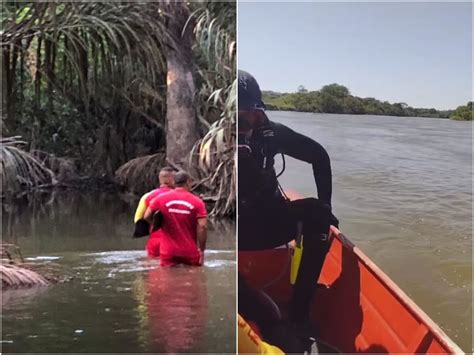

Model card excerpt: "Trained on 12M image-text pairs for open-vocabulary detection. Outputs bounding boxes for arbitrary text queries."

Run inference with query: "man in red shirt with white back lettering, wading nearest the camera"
[145,171,207,266]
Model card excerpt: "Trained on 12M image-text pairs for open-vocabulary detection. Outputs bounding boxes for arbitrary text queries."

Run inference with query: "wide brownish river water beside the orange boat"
[269,112,473,352]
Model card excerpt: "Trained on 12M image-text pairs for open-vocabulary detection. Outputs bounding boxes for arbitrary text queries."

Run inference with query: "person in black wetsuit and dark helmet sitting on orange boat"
[238,70,339,324]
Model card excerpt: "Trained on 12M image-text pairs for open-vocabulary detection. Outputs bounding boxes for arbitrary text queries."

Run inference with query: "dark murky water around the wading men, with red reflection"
[2,191,236,353]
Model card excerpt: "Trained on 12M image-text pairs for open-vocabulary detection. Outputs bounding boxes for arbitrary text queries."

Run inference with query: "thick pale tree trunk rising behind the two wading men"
[165,1,199,166]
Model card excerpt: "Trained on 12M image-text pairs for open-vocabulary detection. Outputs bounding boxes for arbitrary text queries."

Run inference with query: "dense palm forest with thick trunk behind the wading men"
[1,1,236,215]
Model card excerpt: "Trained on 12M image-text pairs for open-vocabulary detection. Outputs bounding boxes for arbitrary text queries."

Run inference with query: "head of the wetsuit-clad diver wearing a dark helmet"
[238,70,268,133]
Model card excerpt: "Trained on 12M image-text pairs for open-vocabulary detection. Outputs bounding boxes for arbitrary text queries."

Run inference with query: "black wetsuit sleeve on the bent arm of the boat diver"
[273,122,332,206]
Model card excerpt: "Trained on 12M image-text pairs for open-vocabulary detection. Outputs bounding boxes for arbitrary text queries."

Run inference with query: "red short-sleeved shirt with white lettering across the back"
[150,187,207,258]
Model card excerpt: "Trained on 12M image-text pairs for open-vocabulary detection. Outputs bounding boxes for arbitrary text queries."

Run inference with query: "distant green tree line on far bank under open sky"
[262,84,473,120]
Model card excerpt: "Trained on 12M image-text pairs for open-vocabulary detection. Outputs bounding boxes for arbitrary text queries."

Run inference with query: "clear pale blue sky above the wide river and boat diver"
[238,2,473,109]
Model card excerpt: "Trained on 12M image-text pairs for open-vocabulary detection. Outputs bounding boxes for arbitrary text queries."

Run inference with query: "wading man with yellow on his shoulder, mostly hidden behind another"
[134,167,175,258]
